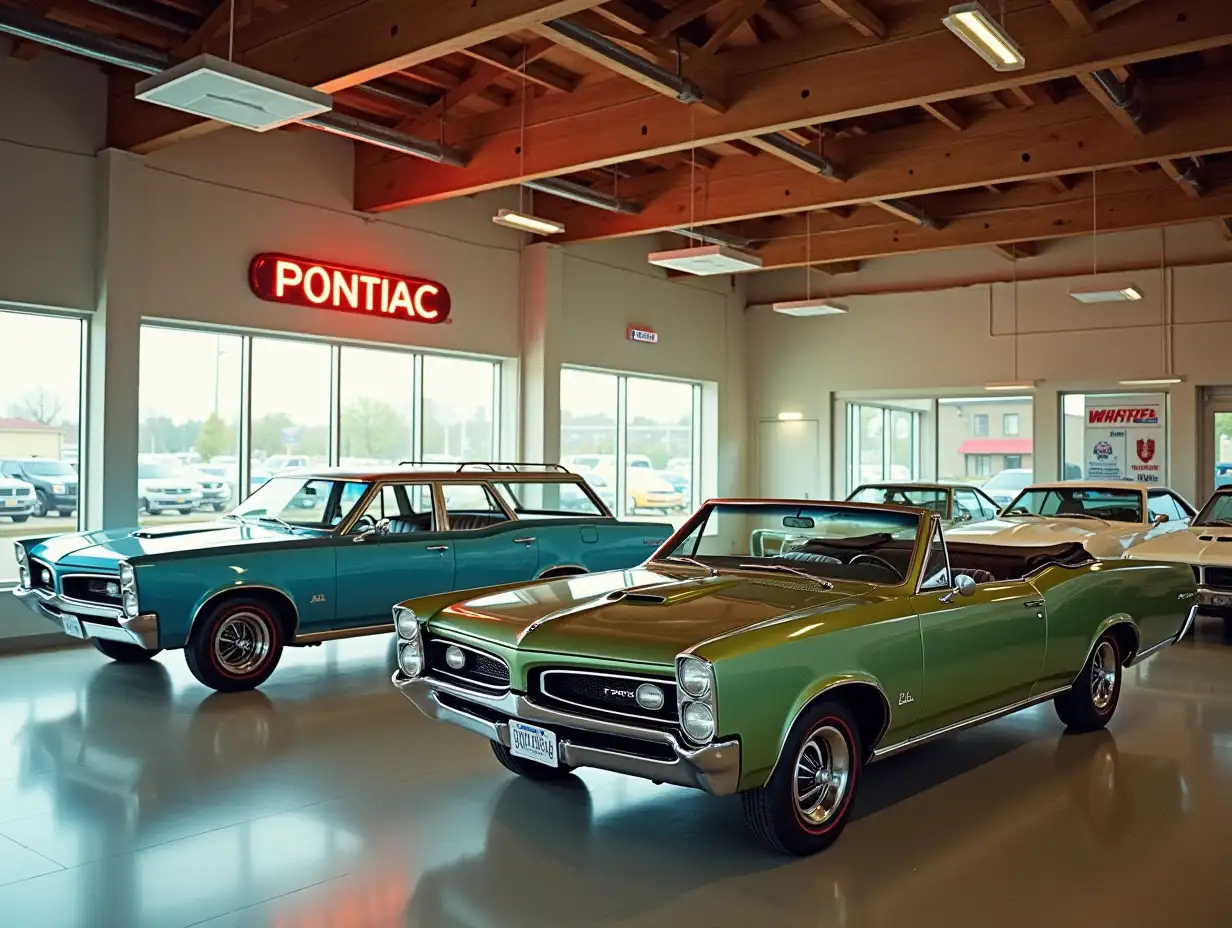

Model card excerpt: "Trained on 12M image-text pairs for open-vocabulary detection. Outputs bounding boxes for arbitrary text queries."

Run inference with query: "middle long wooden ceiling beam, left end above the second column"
[534,74,1232,242]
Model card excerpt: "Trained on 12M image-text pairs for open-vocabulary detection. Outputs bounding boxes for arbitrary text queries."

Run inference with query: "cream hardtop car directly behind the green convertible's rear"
[946,481,1194,558]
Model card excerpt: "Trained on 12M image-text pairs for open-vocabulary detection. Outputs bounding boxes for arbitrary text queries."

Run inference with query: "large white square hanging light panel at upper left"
[137,54,334,132]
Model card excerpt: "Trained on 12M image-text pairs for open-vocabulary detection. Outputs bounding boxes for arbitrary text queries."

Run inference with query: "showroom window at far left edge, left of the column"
[0,304,83,582]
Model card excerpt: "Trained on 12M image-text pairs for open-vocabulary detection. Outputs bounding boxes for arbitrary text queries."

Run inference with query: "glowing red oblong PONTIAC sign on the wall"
[248,254,450,324]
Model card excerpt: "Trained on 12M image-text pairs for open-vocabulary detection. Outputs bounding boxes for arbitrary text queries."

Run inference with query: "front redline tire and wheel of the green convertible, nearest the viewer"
[740,700,864,857]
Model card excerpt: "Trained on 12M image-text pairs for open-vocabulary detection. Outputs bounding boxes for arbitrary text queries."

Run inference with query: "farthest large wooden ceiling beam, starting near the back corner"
[758,173,1232,270]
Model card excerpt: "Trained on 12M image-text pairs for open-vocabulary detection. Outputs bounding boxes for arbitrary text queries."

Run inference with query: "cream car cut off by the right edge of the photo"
[1125,487,1232,622]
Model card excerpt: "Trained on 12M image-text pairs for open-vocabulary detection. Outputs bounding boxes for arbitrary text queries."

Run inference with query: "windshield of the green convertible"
[655,503,923,585]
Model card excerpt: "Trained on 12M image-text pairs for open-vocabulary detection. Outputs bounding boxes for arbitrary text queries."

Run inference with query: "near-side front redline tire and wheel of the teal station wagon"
[184,595,283,693]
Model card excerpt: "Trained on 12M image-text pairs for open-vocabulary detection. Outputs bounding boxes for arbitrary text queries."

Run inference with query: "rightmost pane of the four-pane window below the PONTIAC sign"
[423,355,500,461]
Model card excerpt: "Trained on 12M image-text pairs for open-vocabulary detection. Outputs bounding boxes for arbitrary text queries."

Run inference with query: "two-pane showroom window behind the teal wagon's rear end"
[561,368,701,524]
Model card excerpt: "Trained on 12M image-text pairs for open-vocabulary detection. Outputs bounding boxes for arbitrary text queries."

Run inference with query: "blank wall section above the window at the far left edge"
[0,38,107,309]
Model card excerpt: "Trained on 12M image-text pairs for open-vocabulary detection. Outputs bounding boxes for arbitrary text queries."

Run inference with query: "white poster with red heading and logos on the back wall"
[1083,393,1168,484]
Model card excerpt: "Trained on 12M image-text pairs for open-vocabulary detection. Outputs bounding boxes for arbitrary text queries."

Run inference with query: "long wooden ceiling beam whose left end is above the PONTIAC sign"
[356,4,1232,211]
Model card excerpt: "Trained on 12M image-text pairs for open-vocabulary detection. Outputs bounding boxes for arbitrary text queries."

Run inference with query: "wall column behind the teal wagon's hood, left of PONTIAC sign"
[84,149,142,530]
